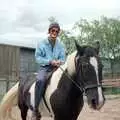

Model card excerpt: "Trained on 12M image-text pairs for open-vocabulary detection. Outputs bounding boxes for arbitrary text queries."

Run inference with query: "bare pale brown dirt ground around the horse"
[7,97,120,120]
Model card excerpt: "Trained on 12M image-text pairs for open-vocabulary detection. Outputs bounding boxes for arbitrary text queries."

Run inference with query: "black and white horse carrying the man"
[0,42,105,120]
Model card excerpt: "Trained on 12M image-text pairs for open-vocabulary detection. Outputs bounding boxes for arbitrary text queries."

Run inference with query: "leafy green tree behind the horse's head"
[74,16,120,77]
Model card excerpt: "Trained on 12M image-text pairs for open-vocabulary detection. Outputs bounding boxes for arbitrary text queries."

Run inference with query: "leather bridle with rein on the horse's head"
[60,54,102,93]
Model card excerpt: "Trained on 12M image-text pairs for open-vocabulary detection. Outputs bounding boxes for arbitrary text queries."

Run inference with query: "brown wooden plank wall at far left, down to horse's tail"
[0,45,20,97]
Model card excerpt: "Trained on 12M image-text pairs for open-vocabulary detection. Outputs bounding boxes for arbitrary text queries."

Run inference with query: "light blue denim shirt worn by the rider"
[35,38,65,66]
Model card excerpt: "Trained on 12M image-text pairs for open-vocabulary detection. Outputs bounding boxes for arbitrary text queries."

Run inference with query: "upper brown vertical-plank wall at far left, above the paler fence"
[0,45,20,79]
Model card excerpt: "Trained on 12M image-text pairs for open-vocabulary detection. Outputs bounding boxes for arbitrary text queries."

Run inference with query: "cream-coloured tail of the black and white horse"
[0,83,19,120]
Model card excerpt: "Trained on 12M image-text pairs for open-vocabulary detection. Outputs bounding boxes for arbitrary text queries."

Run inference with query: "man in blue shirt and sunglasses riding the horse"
[34,22,65,116]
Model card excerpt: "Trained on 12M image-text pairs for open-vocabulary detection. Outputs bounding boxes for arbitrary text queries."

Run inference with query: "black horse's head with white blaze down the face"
[75,43,105,109]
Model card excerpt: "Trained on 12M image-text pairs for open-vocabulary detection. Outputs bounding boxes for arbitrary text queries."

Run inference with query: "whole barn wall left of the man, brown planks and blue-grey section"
[0,44,36,97]
